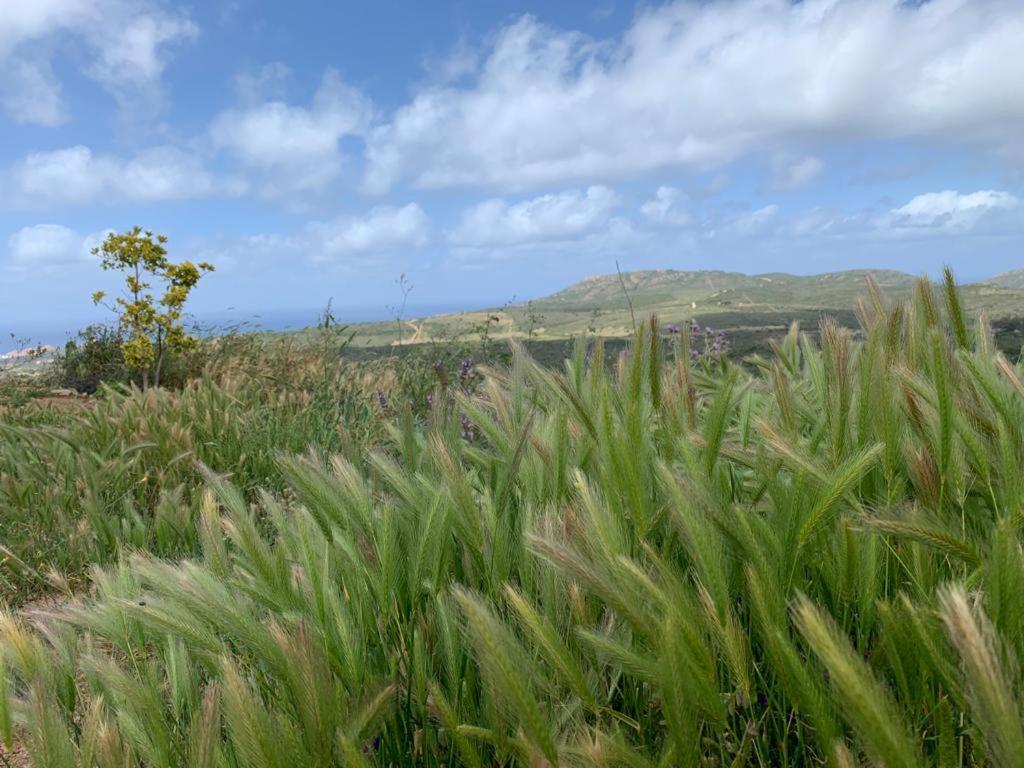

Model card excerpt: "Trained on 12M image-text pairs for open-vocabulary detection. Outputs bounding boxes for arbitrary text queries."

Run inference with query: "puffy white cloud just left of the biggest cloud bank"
[210,71,373,197]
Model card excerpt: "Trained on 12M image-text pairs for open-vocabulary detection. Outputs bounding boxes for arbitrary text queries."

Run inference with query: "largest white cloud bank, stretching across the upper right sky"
[365,0,1024,193]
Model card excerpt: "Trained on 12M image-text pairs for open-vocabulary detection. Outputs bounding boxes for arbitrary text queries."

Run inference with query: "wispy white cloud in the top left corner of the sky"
[0,0,199,125]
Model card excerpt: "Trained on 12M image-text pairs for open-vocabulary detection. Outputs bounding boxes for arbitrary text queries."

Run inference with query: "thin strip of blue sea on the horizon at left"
[0,302,487,353]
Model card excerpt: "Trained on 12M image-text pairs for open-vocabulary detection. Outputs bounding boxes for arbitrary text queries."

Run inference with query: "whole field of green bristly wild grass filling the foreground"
[0,274,1024,768]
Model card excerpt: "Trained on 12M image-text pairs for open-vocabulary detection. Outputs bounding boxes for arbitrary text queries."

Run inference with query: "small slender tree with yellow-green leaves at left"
[92,226,213,388]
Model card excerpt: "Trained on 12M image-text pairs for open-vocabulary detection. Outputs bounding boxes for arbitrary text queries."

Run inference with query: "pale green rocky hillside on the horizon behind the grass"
[337,269,1024,346]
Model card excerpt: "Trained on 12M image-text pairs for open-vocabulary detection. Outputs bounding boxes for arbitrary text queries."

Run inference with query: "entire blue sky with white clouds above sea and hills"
[0,0,1024,332]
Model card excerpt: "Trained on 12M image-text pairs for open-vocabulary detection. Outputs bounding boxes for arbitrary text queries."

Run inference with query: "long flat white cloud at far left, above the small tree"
[6,145,242,207]
